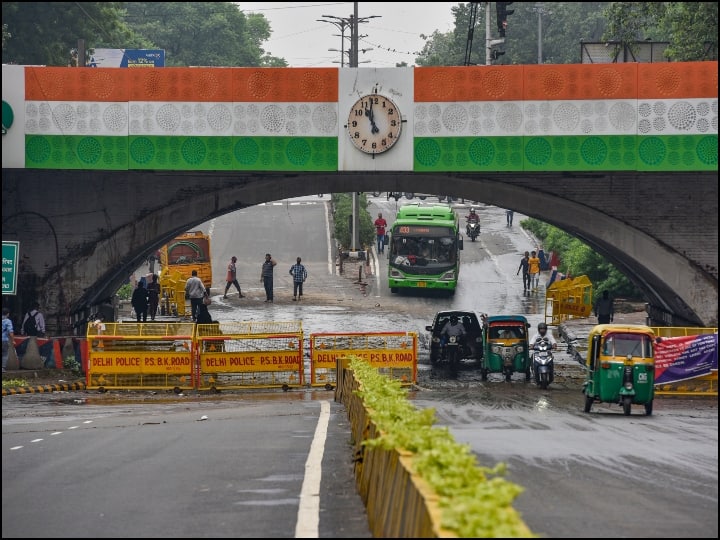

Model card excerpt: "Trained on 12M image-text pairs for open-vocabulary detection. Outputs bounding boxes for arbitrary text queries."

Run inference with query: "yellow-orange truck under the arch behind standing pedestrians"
[160,231,212,316]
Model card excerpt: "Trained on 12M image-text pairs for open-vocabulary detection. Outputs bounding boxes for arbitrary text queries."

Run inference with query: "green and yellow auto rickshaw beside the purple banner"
[583,324,656,416]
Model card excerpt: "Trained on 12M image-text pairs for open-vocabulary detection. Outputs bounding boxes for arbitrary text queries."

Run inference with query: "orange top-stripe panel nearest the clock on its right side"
[415,66,523,102]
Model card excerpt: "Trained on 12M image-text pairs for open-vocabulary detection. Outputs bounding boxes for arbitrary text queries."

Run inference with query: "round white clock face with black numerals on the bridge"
[347,94,402,154]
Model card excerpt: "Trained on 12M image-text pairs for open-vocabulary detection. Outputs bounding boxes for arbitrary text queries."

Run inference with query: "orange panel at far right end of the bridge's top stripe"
[638,61,718,99]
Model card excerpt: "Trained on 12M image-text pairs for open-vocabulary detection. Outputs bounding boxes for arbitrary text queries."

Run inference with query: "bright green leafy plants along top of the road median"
[350,358,536,538]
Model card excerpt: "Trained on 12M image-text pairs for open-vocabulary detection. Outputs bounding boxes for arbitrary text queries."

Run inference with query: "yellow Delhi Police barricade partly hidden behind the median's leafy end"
[310,332,417,390]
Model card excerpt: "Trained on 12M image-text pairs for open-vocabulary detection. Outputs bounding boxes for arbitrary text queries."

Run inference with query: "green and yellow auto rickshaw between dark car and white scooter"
[480,315,530,382]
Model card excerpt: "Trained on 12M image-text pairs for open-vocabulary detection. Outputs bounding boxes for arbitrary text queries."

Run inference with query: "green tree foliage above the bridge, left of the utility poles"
[2,2,287,67]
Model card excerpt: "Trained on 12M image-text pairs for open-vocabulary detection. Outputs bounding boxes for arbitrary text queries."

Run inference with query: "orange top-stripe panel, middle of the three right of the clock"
[523,63,638,101]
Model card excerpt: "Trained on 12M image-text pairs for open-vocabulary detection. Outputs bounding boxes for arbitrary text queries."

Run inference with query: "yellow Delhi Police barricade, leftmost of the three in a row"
[86,322,195,393]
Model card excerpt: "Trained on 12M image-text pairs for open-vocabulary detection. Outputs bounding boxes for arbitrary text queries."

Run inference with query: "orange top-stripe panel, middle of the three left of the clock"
[126,68,232,102]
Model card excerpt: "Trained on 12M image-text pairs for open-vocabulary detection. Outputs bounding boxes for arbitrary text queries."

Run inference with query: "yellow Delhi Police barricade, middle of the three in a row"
[197,321,304,391]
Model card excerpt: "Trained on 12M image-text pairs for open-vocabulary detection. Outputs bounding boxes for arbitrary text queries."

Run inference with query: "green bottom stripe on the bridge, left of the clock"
[25,135,338,171]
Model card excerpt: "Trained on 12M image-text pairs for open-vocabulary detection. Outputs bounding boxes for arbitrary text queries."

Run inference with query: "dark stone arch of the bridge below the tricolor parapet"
[3,170,718,327]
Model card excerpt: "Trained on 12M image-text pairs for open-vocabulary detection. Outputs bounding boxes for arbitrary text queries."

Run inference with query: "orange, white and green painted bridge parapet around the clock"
[2,62,718,172]
